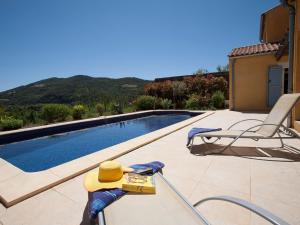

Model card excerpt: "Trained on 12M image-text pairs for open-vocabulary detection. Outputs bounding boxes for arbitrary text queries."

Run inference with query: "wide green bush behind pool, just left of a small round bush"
[42,104,70,123]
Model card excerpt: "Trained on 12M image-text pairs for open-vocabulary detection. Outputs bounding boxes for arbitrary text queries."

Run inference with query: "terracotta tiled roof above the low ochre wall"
[228,43,279,57]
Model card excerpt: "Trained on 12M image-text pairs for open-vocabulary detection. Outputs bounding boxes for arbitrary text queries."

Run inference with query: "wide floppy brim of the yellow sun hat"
[84,169,124,192]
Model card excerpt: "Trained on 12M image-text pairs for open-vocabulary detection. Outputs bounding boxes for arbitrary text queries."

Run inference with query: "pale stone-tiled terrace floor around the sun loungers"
[0,110,300,225]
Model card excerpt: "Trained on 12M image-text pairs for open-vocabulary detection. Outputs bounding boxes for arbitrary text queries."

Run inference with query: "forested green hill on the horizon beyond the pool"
[0,75,149,106]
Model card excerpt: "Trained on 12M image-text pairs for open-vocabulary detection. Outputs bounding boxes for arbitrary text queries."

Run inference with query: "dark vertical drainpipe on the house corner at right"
[280,0,295,127]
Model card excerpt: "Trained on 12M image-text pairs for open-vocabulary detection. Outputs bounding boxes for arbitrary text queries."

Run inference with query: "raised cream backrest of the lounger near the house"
[256,93,300,137]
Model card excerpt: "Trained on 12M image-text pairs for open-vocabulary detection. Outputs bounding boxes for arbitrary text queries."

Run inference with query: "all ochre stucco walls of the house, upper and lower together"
[229,0,300,132]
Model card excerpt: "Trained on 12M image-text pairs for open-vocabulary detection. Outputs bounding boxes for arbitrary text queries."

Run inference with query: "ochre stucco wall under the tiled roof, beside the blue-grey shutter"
[229,54,288,111]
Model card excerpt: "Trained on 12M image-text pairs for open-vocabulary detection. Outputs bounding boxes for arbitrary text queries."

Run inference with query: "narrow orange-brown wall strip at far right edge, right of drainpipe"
[293,0,300,132]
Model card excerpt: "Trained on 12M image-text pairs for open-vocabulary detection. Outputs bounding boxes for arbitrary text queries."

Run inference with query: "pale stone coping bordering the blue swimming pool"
[0,110,214,207]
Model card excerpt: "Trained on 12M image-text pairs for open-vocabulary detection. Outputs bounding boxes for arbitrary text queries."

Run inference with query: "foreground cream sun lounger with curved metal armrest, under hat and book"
[98,173,288,225]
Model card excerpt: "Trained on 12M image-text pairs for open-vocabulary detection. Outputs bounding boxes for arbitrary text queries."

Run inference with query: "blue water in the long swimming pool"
[0,114,191,172]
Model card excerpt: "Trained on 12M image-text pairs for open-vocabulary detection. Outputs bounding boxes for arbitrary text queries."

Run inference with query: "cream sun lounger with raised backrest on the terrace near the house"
[190,93,300,154]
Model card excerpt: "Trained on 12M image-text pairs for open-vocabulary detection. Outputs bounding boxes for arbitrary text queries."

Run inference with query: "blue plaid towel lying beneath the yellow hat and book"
[88,161,165,219]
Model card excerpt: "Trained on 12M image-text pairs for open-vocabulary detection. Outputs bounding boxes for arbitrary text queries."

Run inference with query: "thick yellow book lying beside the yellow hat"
[122,173,155,194]
